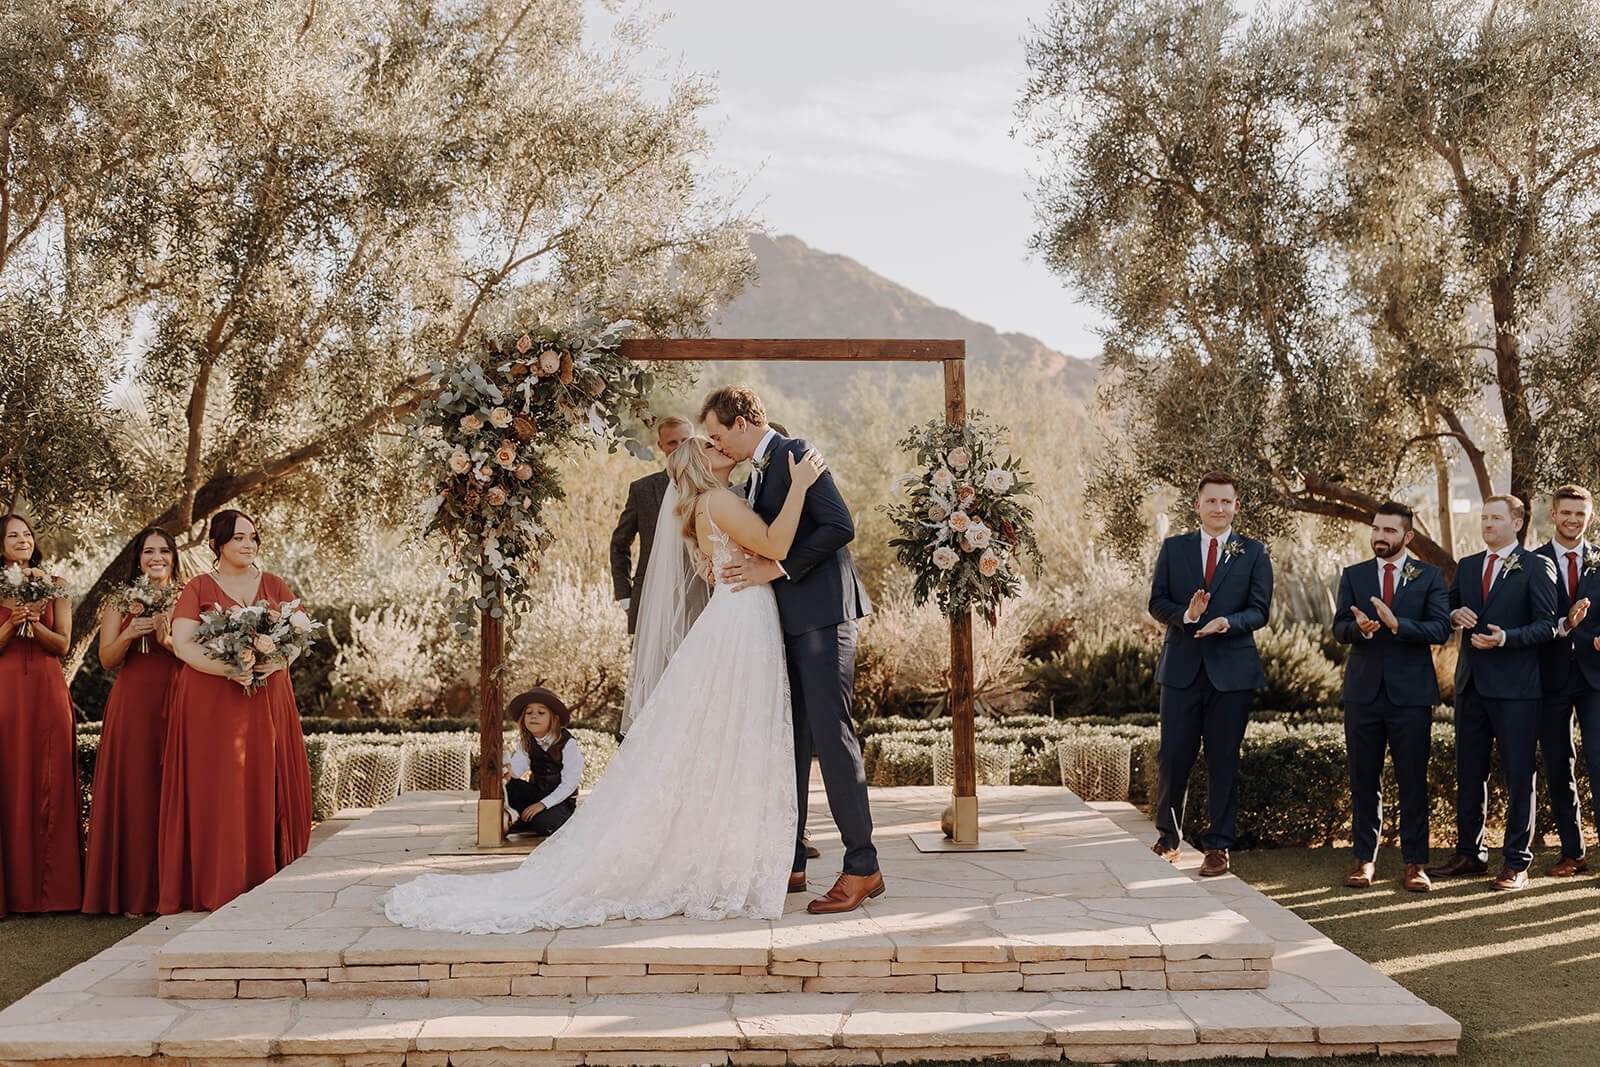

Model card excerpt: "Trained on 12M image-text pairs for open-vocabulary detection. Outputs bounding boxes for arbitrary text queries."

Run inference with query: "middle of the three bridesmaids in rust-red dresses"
[83,528,182,915]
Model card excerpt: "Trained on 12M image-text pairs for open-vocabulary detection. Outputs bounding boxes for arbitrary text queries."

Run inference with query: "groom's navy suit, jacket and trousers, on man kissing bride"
[746,435,878,877]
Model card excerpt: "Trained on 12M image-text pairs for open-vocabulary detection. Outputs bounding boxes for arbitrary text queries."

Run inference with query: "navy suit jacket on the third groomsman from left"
[1450,545,1557,701]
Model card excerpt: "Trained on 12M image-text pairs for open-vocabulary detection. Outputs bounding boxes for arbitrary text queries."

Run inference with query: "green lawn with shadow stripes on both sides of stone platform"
[0,848,1600,1067]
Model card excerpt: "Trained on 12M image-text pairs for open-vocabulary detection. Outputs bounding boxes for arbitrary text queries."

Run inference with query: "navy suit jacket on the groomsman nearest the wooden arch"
[1150,531,1272,693]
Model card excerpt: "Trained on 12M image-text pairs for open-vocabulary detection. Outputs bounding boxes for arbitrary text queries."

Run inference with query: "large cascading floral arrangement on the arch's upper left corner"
[411,322,653,637]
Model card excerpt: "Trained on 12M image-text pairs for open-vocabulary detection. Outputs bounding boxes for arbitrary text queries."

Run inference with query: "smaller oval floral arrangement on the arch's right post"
[883,411,1038,625]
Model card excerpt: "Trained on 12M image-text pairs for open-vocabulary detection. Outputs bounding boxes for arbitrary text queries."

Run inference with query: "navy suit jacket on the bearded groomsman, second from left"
[1333,558,1450,707]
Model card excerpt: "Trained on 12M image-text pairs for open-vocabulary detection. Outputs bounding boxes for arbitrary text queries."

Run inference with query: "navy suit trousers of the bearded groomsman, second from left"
[1344,697,1434,864]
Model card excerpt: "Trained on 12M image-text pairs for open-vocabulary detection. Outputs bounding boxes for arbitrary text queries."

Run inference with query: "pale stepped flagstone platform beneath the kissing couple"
[0,787,1461,1067]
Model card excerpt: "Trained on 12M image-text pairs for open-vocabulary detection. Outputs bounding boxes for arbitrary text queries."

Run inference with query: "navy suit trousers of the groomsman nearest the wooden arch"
[1155,681,1254,849]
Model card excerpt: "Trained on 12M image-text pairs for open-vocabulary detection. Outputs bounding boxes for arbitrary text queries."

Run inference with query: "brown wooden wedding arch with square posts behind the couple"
[477,338,1014,851]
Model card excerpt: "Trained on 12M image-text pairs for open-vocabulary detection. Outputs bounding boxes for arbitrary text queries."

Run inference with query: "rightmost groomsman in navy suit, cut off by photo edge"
[1539,485,1600,878]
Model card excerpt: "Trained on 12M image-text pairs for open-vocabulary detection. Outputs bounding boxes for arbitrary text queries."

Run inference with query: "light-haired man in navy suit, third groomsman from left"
[1427,494,1560,889]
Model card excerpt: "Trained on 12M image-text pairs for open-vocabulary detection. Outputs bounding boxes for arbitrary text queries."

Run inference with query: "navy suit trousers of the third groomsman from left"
[1456,681,1542,870]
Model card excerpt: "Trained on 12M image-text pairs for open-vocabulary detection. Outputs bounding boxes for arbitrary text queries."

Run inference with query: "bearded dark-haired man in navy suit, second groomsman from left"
[1333,501,1450,893]
